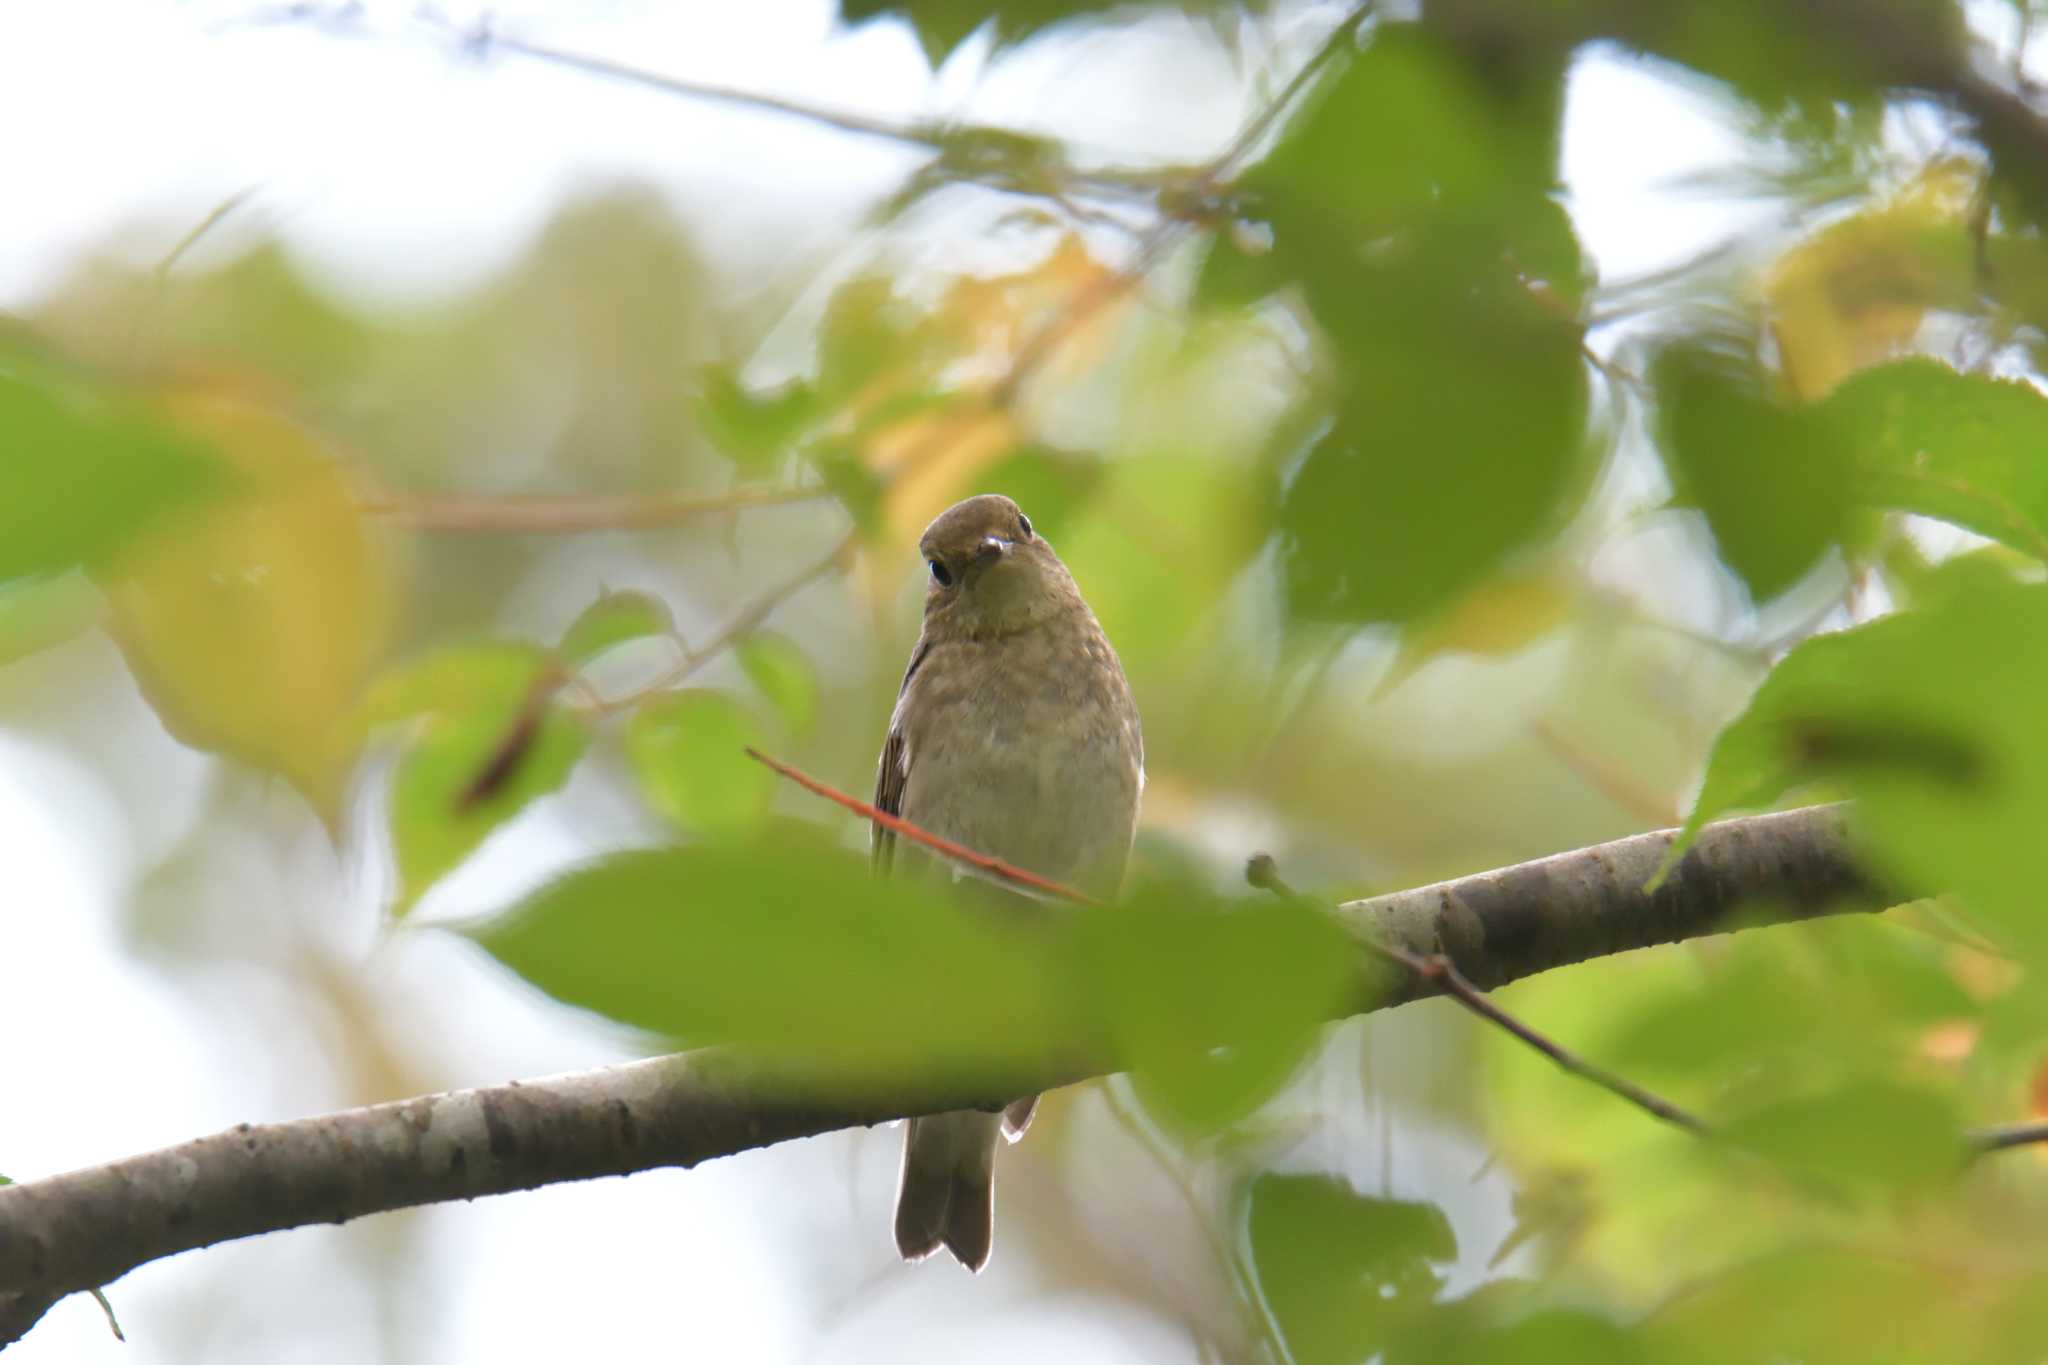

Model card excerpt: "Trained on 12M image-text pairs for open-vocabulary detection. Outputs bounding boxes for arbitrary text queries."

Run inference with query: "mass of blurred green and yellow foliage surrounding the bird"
[19,0,2048,1365]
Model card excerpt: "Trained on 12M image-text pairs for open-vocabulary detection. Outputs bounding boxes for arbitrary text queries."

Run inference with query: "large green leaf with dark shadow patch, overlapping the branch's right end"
[1673,585,2048,952]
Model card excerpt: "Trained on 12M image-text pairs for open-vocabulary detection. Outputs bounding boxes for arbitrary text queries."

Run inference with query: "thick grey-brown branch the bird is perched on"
[0,806,1892,1345]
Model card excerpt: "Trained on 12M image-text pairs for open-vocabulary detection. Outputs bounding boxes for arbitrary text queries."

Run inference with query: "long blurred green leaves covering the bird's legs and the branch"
[471,855,1352,1097]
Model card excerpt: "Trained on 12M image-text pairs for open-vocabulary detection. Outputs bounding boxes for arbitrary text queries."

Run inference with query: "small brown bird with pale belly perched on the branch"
[874,493,1145,1271]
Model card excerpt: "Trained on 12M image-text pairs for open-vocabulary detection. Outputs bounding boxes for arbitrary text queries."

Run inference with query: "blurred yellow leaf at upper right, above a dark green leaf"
[1763,158,1982,399]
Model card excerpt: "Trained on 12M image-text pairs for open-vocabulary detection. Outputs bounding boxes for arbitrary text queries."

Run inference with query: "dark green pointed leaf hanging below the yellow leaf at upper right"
[1655,339,1849,602]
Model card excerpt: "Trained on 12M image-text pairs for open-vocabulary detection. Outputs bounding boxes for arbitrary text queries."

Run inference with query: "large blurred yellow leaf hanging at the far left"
[98,393,397,823]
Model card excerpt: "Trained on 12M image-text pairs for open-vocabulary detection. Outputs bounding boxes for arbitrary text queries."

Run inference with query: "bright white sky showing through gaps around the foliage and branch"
[0,0,1810,1365]
